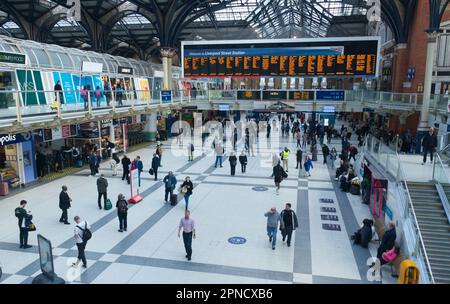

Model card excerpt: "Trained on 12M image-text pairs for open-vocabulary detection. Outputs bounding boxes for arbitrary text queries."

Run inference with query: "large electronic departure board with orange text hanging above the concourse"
[182,37,379,78]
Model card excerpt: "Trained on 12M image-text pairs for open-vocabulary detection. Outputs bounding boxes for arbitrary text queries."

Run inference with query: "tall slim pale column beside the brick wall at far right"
[418,31,437,132]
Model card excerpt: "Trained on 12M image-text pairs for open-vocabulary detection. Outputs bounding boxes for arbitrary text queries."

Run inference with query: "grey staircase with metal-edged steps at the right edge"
[407,182,450,284]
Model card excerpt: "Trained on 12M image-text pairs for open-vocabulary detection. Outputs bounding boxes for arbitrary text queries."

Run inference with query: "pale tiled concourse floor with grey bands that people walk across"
[0,120,386,284]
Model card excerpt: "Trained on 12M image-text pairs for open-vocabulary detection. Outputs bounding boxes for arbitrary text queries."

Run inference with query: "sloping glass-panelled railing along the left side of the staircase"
[364,135,434,284]
